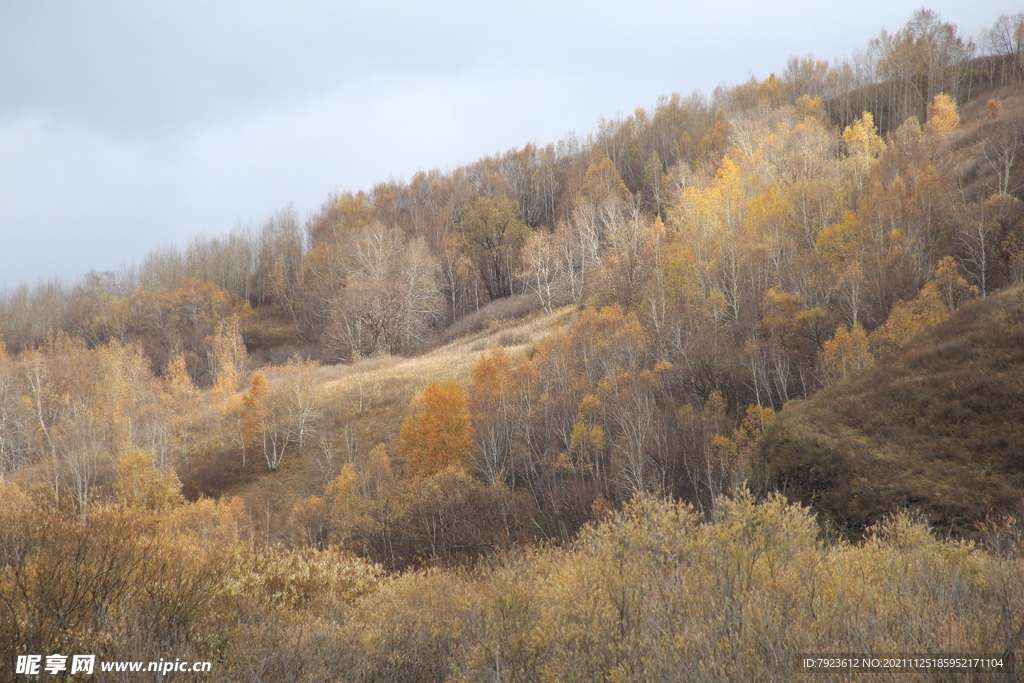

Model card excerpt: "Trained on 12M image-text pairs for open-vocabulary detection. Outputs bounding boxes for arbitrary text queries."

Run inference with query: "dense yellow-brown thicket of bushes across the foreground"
[0,482,1024,683]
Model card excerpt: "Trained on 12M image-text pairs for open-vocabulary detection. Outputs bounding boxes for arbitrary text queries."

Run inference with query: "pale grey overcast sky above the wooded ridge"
[0,0,1021,289]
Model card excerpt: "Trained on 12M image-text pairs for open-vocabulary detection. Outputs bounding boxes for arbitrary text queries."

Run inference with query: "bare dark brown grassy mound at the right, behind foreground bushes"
[755,286,1024,537]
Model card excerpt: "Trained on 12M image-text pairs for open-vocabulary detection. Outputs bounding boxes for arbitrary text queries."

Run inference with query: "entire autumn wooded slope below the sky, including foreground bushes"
[0,10,1024,680]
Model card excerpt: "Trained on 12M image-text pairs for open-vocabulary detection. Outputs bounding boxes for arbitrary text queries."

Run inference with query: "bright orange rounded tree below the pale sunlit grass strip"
[399,380,474,476]
